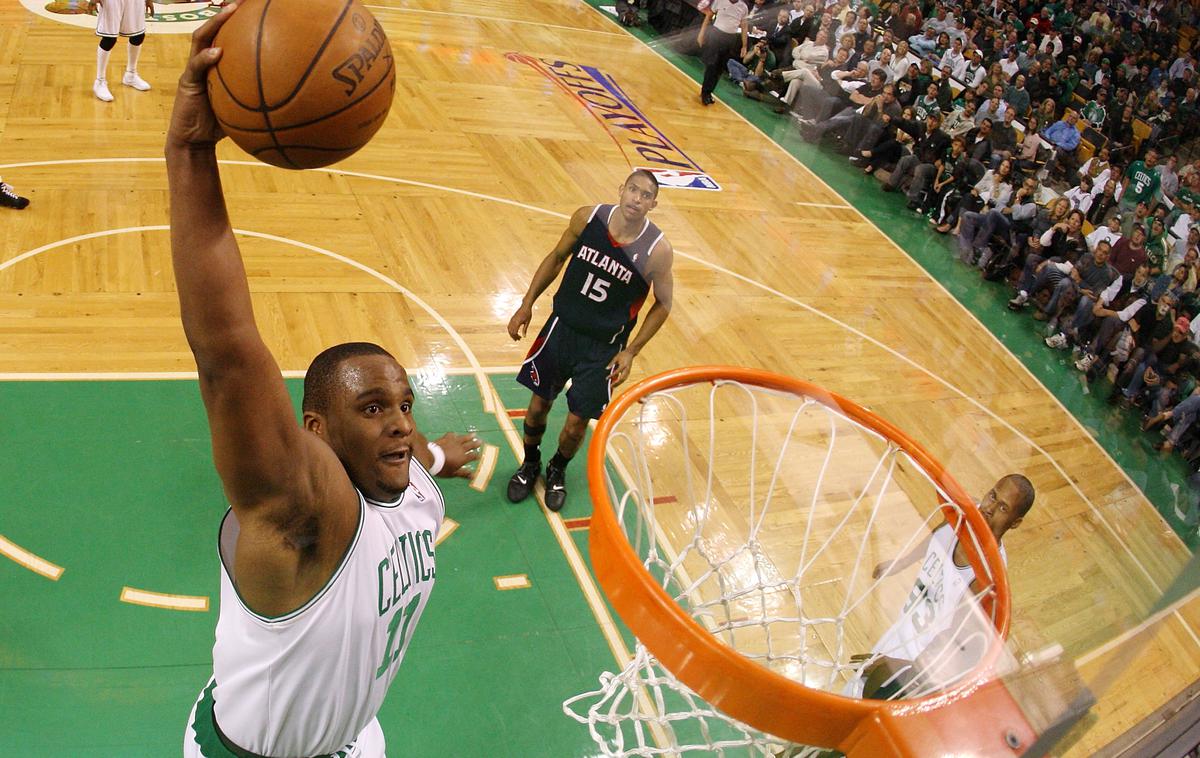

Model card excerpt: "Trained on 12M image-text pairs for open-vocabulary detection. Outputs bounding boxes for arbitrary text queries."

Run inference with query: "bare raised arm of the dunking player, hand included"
[166,6,343,517]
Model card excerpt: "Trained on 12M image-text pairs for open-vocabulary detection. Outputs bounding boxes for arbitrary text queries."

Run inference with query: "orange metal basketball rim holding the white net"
[588,366,1037,757]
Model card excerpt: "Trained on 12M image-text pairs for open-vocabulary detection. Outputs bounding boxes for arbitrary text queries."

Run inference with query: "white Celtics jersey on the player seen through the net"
[872,524,1008,676]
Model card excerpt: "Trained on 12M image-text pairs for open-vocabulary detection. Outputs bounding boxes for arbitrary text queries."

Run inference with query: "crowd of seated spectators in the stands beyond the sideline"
[681,0,1200,515]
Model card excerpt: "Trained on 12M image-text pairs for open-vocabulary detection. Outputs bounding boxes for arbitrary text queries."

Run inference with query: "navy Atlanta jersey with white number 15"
[554,205,662,344]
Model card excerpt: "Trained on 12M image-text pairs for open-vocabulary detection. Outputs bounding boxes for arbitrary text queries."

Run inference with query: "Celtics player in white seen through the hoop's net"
[845,474,1034,699]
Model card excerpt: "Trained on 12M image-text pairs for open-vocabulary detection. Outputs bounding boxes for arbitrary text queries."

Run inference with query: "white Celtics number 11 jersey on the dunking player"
[202,459,445,758]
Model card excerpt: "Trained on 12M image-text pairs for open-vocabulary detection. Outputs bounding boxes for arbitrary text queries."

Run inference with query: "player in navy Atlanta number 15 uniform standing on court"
[508,170,673,511]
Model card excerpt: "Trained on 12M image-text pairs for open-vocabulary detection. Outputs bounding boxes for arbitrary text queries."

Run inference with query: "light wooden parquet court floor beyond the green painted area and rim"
[0,0,1200,756]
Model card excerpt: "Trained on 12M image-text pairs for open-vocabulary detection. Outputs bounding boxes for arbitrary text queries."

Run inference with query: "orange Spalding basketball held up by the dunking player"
[208,0,396,169]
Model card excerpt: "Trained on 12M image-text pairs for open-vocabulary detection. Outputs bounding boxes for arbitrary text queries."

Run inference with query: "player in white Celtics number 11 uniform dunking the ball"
[166,5,478,758]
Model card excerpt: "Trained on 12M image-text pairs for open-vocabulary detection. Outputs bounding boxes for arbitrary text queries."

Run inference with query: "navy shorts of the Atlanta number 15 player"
[517,314,624,419]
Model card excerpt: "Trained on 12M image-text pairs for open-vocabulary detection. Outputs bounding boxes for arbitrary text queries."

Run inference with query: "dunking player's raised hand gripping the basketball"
[167,4,238,149]
